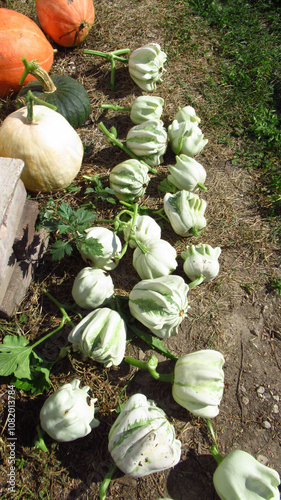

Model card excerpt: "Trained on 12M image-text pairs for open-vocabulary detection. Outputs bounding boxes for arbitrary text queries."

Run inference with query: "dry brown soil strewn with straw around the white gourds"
[0,0,281,500]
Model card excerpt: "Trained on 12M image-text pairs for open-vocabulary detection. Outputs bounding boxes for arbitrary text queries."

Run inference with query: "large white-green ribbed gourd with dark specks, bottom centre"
[108,393,181,477]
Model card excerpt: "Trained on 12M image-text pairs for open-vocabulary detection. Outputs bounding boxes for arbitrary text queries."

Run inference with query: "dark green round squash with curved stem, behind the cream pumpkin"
[17,57,91,128]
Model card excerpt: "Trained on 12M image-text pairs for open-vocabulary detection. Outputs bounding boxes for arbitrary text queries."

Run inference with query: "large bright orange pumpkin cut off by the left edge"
[0,8,54,97]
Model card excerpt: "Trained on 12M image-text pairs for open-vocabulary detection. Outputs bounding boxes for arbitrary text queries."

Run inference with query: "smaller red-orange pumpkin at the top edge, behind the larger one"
[35,0,95,47]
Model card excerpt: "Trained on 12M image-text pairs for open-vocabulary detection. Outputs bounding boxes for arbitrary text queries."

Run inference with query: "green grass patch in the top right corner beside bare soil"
[166,0,281,221]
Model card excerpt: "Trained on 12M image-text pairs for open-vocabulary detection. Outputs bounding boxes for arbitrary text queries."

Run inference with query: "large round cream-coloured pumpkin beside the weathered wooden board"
[0,105,84,192]
